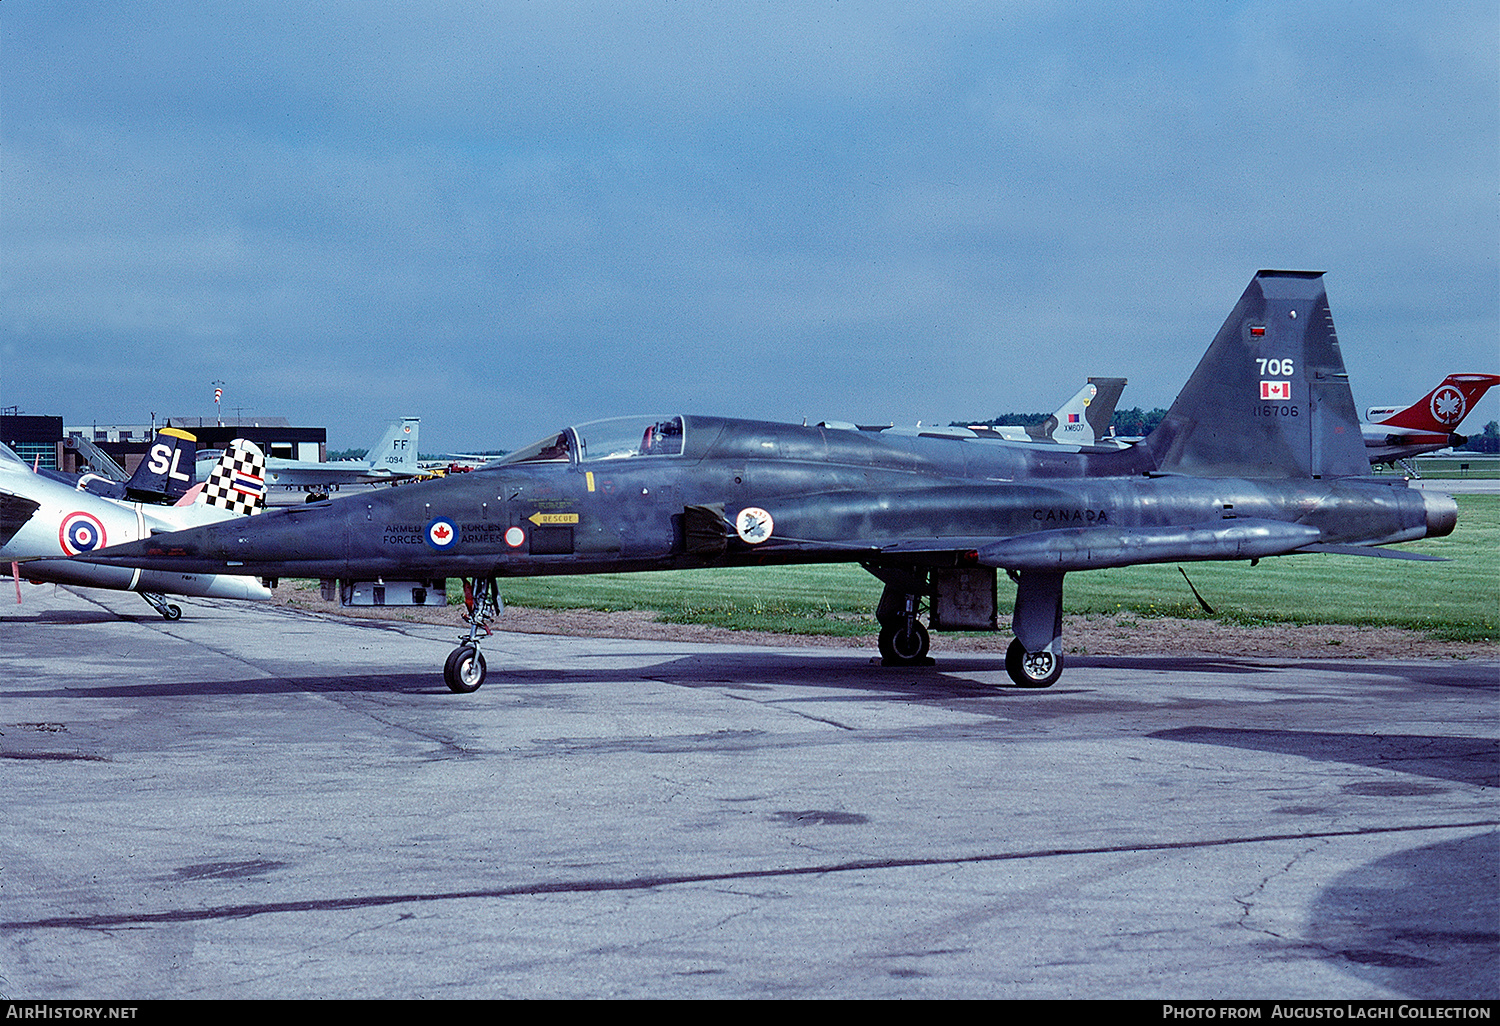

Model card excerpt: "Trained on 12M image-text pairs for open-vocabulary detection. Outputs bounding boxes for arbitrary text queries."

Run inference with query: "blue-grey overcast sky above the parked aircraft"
[0,0,1500,452]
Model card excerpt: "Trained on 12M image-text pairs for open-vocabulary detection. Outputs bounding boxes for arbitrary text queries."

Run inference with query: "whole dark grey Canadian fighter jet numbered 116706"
[80,272,1458,692]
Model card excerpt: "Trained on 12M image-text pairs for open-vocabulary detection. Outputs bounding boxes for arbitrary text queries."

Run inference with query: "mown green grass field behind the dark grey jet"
[474,495,1500,641]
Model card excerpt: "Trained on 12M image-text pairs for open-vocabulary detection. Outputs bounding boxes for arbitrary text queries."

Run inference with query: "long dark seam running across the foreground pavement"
[0,819,1500,932]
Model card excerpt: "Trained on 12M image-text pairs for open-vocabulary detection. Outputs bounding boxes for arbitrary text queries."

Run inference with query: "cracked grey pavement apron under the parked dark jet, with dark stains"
[0,587,1500,999]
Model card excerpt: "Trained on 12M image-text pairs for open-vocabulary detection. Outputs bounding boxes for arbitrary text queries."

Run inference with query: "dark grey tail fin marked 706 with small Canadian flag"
[1142,270,1370,479]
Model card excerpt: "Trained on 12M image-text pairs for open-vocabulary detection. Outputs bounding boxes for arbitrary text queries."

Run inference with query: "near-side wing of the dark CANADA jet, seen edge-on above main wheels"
[980,518,1320,572]
